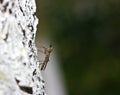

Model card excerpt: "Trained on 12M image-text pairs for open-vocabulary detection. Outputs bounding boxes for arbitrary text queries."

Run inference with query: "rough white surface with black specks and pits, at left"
[0,0,45,95]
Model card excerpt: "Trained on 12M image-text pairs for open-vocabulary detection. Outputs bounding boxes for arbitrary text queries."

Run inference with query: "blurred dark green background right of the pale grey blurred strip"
[36,0,120,95]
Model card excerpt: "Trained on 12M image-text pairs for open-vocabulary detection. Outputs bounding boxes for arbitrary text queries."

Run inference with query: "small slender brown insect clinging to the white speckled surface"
[40,45,53,70]
